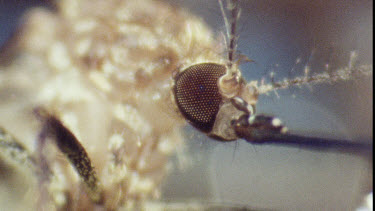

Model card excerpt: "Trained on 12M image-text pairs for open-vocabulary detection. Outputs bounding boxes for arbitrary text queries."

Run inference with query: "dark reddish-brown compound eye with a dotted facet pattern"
[174,63,226,132]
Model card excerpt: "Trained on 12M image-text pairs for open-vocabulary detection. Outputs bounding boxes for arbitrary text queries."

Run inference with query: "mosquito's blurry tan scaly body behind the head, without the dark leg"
[0,0,226,210]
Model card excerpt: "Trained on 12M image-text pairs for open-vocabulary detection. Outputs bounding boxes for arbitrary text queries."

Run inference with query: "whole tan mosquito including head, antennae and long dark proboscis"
[1,0,372,209]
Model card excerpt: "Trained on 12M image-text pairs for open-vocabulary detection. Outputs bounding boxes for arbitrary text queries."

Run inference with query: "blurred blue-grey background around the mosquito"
[0,0,373,210]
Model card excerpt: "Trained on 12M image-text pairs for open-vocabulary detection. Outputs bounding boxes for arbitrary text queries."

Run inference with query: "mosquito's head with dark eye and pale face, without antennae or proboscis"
[173,63,253,141]
